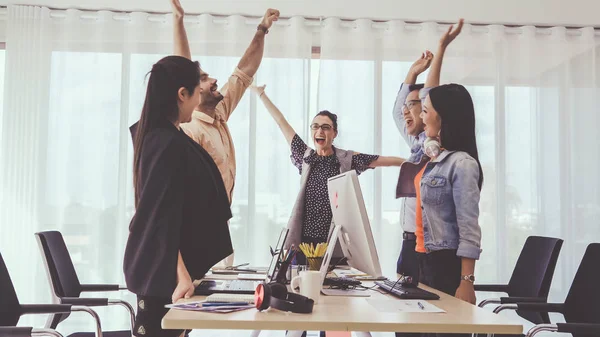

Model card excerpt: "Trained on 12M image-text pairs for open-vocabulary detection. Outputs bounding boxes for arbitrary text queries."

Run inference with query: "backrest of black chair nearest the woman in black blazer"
[35,231,81,329]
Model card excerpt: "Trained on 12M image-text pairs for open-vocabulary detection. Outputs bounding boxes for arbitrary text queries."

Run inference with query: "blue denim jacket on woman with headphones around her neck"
[420,150,481,260]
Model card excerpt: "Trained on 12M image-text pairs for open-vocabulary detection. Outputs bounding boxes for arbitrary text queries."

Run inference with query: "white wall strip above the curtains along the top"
[0,0,600,27]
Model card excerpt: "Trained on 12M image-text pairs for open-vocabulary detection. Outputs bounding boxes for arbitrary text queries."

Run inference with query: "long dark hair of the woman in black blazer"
[133,56,200,207]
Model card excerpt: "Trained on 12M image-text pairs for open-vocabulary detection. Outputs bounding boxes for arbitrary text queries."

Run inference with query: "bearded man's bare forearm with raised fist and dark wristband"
[238,8,279,77]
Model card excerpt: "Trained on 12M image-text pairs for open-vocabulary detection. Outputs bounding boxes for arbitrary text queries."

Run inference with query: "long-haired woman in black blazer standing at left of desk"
[123,56,233,337]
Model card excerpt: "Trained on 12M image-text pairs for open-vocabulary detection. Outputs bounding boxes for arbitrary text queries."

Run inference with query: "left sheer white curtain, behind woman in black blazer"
[0,6,312,333]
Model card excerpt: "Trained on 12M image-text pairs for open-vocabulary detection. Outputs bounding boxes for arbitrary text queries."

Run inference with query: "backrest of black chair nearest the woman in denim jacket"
[508,236,563,324]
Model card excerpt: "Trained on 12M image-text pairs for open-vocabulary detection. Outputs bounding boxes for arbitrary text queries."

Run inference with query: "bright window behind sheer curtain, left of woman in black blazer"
[42,52,131,331]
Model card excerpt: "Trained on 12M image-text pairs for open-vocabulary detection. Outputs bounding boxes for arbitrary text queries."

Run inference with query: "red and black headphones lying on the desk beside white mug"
[254,282,315,314]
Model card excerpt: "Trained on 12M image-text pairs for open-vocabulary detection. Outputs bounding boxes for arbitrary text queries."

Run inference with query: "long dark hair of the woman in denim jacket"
[429,83,483,190]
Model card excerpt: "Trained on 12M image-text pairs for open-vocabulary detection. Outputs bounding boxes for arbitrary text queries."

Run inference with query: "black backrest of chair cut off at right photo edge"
[564,243,600,337]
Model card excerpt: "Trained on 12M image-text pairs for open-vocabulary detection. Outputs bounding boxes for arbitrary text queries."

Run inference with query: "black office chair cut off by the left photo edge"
[0,254,102,337]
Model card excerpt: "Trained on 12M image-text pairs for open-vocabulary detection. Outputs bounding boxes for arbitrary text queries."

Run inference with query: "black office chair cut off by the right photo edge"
[494,243,600,337]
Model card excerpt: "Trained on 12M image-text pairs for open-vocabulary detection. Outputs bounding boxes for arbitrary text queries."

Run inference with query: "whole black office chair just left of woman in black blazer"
[35,231,135,337]
